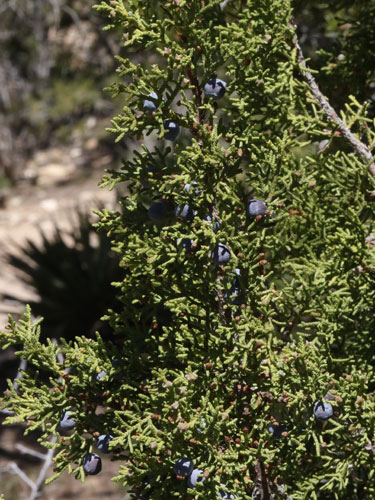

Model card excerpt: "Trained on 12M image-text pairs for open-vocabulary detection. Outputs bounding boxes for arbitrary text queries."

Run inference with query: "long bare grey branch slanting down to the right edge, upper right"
[290,22,375,177]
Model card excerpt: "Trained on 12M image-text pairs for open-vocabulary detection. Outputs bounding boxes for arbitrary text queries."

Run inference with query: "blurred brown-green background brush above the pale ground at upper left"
[0,0,126,183]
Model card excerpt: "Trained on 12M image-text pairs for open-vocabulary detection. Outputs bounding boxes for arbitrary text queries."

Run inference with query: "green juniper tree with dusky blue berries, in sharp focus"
[1,0,375,500]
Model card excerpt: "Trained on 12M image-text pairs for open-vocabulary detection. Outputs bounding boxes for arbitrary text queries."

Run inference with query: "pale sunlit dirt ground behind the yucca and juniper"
[0,144,129,500]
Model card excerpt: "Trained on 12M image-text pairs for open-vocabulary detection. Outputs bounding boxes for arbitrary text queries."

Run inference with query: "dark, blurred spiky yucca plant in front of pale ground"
[5,210,123,340]
